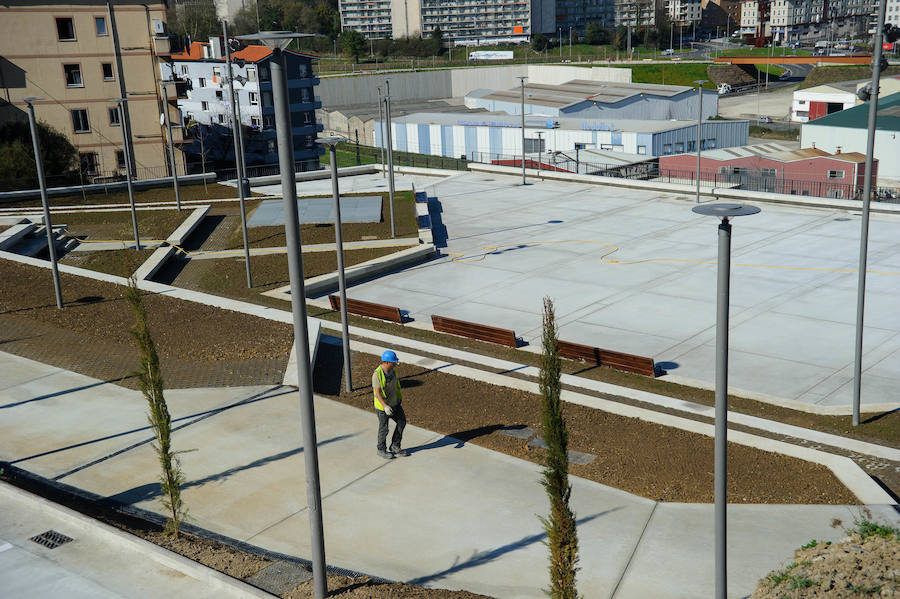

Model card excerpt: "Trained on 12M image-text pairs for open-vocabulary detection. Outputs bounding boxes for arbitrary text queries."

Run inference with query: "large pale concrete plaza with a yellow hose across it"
[300,173,900,407]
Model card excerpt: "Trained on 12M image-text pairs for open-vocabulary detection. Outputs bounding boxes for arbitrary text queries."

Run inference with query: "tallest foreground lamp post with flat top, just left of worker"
[238,31,328,599]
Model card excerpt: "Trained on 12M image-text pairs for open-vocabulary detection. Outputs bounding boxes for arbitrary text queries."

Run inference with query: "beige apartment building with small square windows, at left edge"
[0,0,184,179]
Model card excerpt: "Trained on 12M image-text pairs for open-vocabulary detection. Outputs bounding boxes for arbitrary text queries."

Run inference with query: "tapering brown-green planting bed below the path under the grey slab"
[198,248,398,300]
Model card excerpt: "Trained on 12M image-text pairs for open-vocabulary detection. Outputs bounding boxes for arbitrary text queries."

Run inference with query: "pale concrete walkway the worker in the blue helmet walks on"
[0,353,900,599]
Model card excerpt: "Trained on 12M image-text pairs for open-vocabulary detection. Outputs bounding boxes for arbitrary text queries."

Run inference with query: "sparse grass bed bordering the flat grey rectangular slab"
[228,191,419,250]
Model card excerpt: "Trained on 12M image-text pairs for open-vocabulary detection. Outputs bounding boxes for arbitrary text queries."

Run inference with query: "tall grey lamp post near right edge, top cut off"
[853,2,887,426]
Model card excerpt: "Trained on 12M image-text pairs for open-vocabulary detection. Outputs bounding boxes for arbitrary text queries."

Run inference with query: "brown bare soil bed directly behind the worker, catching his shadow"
[314,344,857,505]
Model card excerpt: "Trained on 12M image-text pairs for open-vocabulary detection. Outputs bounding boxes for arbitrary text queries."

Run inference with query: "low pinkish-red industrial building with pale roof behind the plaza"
[659,143,878,198]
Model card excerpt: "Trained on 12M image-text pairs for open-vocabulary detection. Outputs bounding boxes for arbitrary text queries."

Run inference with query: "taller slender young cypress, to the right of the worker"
[540,297,578,599]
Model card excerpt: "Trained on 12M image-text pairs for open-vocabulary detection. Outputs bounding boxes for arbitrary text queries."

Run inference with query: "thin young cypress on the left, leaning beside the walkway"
[125,276,186,536]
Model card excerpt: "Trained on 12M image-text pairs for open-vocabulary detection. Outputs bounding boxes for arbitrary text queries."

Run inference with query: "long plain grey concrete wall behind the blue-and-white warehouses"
[318,64,631,109]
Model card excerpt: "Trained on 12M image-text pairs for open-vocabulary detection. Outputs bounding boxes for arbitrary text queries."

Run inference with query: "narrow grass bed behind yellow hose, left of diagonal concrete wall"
[59,210,191,241]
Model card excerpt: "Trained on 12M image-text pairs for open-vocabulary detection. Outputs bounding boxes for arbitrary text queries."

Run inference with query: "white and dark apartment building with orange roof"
[160,38,323,170]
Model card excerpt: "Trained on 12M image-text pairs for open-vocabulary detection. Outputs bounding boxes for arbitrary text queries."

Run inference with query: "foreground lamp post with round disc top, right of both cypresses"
[692,204,759,599]
